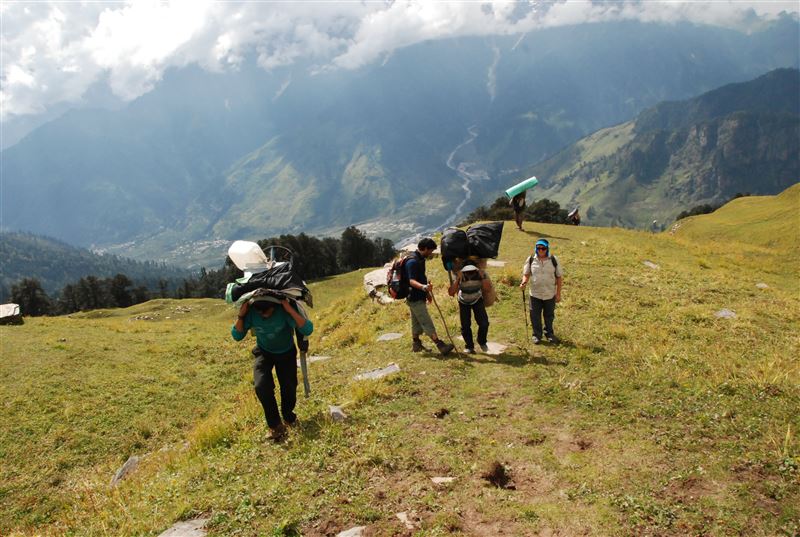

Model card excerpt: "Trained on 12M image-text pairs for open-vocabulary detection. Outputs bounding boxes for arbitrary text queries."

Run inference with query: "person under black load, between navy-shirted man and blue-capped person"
[447,265,491,354]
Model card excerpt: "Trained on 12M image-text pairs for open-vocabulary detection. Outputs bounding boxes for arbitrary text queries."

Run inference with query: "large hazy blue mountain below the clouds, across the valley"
[2,19,798,258]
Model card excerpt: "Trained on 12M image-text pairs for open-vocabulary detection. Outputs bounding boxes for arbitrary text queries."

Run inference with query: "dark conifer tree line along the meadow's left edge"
[10,226,396,317]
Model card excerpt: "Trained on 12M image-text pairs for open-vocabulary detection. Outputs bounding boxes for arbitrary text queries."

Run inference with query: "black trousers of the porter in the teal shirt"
[253,346,297,429]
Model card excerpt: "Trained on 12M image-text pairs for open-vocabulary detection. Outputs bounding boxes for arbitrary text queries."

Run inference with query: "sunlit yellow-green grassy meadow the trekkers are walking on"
[0,187,800,536]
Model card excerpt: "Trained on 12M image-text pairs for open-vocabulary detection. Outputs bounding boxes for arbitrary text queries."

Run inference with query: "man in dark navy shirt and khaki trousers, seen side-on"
[403,237,455,356]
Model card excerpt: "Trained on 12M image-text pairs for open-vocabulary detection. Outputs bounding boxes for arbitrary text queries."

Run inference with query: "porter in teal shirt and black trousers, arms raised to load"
[231,299,314,442]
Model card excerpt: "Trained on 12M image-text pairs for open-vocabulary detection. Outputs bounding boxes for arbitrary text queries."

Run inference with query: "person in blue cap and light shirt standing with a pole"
[520,239,563,344]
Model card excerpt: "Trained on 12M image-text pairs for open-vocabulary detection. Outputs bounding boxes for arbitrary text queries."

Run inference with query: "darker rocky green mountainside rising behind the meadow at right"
[529,69,800,226]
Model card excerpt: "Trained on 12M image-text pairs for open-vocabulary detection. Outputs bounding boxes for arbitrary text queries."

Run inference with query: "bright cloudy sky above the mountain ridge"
[0,0,798,119]
